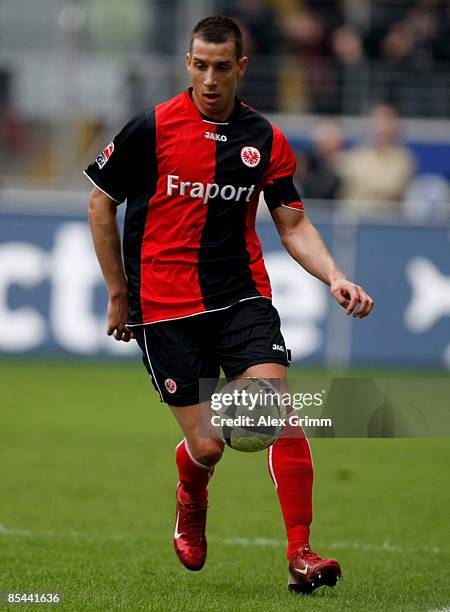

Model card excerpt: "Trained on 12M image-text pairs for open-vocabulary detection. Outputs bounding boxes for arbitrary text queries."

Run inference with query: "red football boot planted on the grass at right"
[288,544,342,594]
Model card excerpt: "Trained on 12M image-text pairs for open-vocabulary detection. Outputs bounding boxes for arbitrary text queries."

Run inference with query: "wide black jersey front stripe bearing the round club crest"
[198,106,273,310]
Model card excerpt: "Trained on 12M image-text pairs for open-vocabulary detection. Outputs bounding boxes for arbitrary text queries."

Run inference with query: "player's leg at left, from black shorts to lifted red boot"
[134,317,223,570]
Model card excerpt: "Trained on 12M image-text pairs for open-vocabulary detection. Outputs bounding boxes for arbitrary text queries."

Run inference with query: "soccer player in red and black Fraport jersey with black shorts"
[85,16,373,592]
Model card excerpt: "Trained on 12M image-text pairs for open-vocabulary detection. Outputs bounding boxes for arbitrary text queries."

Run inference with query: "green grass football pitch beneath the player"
[0,360,450,612]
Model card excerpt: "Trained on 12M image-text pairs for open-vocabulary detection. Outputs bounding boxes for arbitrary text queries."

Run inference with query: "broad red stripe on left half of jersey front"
[141,94,216,321]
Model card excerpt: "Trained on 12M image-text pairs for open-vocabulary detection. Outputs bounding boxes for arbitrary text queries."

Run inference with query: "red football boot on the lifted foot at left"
[173,484,208,572]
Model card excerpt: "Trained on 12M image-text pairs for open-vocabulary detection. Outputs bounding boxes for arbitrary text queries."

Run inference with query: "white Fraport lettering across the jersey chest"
[167,174,255,204]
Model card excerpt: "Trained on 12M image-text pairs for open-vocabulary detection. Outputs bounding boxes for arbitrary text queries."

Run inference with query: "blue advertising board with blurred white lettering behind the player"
[0,213,450,368]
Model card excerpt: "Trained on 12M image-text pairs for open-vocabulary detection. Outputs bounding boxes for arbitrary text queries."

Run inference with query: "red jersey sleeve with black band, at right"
[263,126,304,212]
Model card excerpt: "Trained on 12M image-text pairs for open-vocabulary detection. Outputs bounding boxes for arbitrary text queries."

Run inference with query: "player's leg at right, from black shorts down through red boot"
[221,300,340,593]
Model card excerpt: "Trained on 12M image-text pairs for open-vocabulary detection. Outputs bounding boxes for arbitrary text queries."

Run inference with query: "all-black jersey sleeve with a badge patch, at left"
[84,111,154,204]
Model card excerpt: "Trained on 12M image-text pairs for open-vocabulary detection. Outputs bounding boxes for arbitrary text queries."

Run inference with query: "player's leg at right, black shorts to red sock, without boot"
[214,299,313,554]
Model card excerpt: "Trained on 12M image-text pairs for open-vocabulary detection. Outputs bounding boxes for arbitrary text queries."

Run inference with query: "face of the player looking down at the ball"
[187,38,248,121]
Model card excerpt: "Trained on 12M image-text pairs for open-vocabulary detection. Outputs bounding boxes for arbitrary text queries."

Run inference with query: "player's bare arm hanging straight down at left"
[88,187,132,342]
